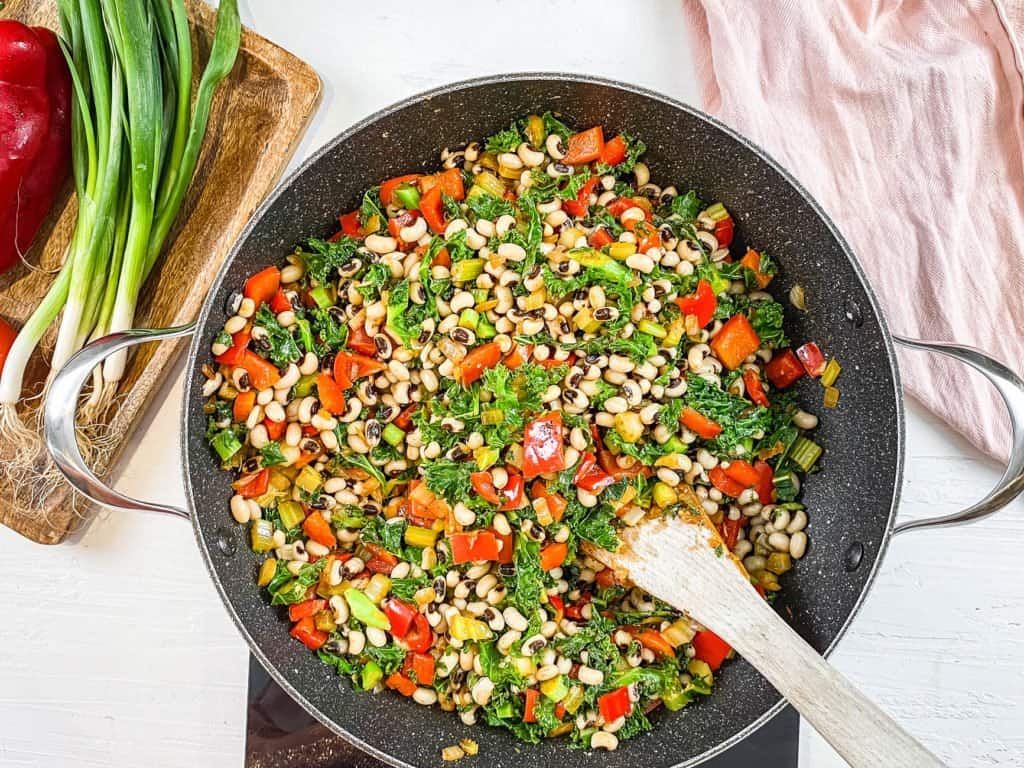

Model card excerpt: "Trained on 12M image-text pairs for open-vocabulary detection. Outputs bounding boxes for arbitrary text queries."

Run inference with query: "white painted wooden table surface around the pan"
[0,0,1024,768]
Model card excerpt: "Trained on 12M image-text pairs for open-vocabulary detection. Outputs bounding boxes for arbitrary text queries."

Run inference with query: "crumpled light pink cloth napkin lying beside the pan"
[683,0,1024,459]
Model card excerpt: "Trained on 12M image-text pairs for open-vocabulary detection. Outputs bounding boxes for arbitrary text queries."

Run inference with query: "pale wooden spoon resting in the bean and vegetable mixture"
[588,510,942,768]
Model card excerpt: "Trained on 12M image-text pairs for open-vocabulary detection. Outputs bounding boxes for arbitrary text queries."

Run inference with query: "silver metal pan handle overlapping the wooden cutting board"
[43,323,196,519]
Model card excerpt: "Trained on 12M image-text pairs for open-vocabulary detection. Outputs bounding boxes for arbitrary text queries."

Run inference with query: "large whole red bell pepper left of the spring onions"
[0,19,71,272]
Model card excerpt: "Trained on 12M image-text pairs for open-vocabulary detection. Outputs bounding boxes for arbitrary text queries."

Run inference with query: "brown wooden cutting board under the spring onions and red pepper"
[0,0,321,544]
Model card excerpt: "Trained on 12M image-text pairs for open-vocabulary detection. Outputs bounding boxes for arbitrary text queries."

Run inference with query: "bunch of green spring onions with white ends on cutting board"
[0,0,242,437]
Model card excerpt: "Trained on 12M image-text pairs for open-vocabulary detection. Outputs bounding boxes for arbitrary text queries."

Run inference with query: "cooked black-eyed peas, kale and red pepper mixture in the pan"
[203,114,839,759]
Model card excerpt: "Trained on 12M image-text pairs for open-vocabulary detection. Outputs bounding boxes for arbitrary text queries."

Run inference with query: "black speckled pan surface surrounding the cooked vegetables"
[182,74,903,768]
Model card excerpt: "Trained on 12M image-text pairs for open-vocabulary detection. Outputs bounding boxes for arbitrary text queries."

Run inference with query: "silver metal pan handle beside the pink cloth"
[893,336,1024,534]
